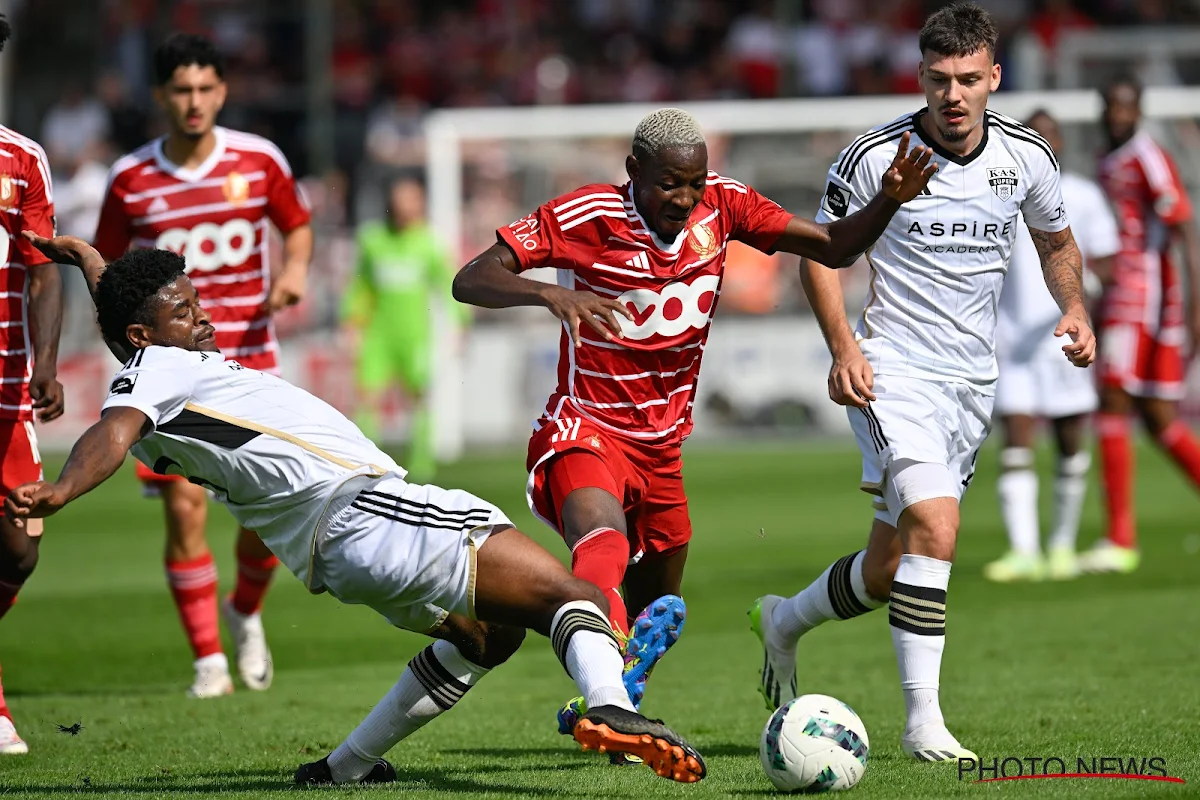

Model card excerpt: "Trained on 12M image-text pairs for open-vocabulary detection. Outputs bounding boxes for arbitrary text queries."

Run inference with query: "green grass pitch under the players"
[0,444,1200,798]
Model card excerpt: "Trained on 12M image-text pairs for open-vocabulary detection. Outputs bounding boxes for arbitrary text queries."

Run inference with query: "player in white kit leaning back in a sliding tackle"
[5,231,704,784]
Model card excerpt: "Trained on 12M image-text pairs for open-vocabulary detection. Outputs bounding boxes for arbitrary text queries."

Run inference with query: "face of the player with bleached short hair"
[625,145,708,242]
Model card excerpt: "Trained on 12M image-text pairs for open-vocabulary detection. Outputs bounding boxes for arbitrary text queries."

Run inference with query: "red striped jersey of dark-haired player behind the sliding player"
[95,127,310,371]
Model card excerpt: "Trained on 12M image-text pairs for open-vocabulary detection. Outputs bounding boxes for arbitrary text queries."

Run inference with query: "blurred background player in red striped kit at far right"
[1079,78,1200,572]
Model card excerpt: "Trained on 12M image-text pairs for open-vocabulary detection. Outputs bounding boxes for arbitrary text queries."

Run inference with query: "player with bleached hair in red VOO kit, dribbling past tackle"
[455,108,936,733]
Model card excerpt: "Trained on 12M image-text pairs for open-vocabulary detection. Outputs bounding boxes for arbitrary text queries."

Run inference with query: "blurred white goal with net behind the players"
[426,88,1200,455]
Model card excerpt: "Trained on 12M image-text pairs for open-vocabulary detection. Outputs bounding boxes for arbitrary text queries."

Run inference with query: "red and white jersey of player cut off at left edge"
[0,126,54,420]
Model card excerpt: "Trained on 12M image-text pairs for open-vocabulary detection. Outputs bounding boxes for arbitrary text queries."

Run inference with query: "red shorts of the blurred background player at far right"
[1097,323,1186,399]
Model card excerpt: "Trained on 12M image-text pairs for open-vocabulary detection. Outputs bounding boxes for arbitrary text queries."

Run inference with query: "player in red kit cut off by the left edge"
[0,14,62,756]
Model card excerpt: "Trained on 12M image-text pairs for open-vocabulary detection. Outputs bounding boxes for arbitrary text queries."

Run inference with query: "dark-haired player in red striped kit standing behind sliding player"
[95,34,312,697]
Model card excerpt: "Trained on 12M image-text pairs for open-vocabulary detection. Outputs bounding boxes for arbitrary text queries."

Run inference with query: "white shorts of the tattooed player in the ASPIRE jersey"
[846,375,992,528]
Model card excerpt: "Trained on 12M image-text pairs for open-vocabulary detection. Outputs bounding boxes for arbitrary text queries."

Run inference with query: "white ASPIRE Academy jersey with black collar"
[816,109,1068,393]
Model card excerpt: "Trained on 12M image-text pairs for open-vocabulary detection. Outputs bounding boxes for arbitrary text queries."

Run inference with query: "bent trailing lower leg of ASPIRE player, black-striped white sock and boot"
[750,518,902,710]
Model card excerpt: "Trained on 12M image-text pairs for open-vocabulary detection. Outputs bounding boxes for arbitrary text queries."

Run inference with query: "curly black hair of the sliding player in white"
[96,249,185,344]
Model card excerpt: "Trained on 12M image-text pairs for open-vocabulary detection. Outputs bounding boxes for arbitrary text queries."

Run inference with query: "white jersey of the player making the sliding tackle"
[104,347,404,588]
